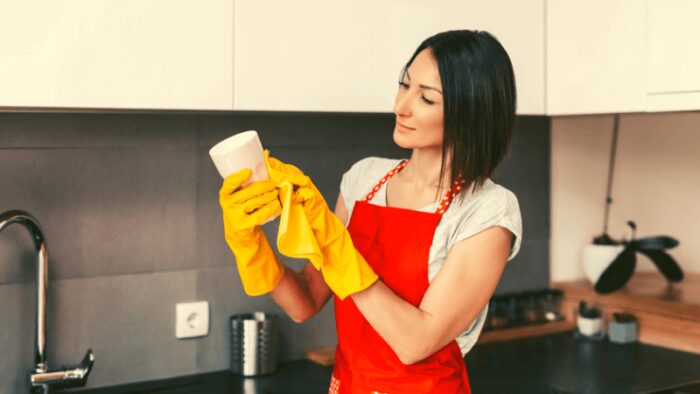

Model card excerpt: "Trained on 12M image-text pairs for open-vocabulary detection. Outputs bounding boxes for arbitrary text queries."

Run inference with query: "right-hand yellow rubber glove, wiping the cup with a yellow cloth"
[265,150,379,300]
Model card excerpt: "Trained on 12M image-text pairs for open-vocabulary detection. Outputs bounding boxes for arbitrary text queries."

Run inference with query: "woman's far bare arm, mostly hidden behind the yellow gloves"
[270,194,348,323]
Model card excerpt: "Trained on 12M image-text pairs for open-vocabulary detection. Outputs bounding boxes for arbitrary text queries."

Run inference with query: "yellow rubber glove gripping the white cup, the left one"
[219,169,285,296]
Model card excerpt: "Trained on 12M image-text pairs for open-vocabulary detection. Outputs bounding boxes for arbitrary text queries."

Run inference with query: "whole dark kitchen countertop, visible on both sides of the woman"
[73,332,700,394]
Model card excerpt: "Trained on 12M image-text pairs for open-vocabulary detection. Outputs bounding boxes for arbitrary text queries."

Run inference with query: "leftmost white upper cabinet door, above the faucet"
[0,0,233,109]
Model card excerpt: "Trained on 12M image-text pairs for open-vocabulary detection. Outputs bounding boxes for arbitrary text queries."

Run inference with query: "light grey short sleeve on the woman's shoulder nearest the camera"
[451,186,522,261]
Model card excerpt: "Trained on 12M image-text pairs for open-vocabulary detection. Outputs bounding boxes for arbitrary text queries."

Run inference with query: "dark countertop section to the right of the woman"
[466,332,700,394]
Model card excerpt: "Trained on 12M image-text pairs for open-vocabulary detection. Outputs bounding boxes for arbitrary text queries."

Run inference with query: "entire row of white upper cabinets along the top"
[0,0,700,115]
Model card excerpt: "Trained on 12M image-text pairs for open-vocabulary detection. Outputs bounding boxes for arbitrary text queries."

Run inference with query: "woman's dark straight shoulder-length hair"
[401,30,516,199]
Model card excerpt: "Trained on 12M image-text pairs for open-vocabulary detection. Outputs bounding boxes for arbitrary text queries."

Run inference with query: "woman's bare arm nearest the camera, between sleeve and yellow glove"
[352,223,513,364]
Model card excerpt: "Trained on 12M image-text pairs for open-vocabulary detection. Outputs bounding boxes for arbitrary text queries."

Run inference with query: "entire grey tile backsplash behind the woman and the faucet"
[0,113,550,393]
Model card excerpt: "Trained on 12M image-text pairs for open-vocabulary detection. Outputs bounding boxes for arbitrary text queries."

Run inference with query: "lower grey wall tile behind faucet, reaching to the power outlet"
[0,270,197,394]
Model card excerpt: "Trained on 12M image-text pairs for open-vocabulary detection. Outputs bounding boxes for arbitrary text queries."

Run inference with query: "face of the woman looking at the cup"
[394,49,444,149]
